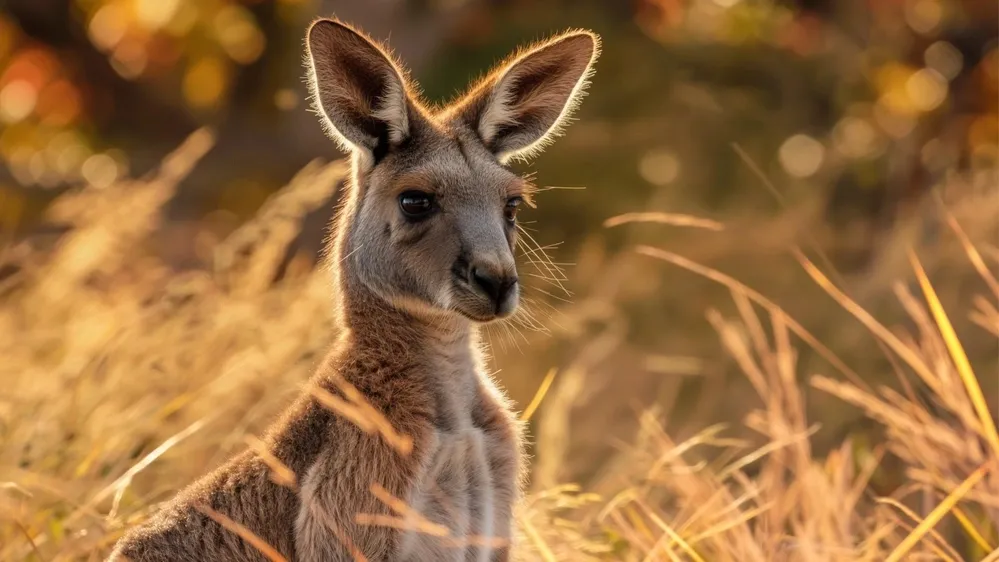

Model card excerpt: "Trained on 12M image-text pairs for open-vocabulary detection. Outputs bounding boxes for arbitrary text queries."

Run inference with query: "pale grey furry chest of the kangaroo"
[400,418,516,562]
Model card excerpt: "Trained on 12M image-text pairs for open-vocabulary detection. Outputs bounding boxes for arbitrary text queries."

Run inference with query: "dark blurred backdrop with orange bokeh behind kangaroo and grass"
[0,0,999,492]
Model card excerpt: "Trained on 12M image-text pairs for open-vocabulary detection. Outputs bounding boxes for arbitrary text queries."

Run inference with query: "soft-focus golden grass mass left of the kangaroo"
[0,131,345,560]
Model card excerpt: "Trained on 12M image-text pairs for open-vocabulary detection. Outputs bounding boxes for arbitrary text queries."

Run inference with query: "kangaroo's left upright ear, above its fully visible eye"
[306,19,409,159]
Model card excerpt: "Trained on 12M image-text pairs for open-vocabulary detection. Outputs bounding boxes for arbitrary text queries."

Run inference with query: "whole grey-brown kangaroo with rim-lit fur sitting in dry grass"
[111,15,599,562]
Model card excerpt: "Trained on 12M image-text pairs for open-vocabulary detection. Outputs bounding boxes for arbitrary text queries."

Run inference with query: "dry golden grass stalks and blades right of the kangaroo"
[539,237,999,562]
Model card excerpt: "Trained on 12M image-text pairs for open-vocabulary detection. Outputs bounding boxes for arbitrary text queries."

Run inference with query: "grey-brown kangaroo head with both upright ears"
[307,19,599,322]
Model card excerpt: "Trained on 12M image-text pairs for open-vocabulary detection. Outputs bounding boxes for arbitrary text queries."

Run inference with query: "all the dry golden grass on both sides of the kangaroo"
[0,131,999,562]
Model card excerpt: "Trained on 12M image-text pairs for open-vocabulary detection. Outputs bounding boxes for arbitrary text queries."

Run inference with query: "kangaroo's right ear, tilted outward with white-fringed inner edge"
[458,31,600,162]
